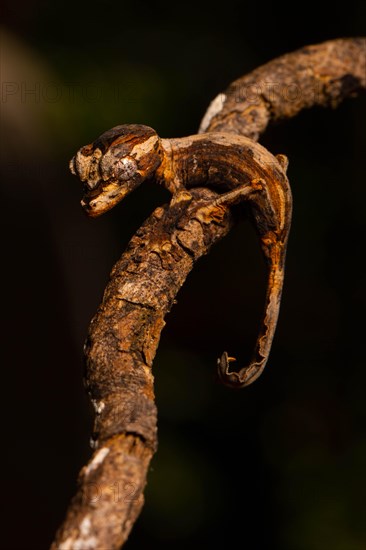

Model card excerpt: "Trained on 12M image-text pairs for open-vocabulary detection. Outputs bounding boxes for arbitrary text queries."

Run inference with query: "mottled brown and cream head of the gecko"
[70,124,161,217]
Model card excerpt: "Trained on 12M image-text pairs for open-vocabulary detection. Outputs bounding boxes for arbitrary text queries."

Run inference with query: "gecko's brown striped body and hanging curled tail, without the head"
[157,133,292,388]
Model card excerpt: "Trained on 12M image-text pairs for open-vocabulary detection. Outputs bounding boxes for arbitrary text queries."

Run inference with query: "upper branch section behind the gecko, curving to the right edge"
[199,38,366,141]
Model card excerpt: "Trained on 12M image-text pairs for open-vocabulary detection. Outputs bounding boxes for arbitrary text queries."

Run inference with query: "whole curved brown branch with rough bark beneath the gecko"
[52,39,366,550]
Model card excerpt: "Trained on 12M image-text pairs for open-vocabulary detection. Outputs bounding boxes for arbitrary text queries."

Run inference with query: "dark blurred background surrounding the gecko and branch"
[0,0,366,550]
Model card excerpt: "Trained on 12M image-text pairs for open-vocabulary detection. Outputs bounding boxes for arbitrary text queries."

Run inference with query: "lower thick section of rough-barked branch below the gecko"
[52,188,232,550]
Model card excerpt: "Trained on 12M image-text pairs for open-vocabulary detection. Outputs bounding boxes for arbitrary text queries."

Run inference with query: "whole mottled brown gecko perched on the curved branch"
[70,125,292,387]
